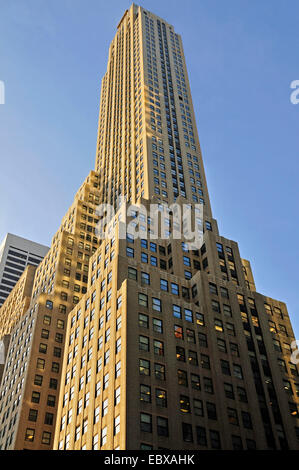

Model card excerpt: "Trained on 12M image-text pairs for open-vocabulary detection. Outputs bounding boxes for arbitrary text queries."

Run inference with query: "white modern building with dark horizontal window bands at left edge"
[0,233,49,307]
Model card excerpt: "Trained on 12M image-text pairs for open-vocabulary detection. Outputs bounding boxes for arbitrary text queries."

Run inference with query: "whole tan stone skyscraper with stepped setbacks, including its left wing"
[0,4,299,450]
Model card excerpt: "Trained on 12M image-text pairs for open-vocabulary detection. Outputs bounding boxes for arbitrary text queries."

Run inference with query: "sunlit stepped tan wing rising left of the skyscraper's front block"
[0,171,99,449]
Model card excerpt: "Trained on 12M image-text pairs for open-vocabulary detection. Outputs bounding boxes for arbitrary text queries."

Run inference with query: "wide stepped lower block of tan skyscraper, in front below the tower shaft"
[54,197,298,450]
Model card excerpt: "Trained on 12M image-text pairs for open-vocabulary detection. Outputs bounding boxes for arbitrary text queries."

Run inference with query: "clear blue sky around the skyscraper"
[0,0,299,339]
